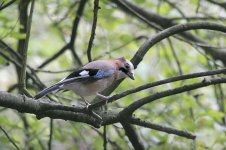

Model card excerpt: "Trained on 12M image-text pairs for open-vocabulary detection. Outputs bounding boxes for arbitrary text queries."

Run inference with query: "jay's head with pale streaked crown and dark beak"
[117,57,135,80]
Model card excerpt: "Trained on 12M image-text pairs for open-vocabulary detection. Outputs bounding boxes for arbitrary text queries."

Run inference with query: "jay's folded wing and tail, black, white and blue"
[34,69,114,99]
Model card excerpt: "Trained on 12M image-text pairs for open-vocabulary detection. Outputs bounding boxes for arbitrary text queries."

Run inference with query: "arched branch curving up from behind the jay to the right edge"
[87,21,226,112]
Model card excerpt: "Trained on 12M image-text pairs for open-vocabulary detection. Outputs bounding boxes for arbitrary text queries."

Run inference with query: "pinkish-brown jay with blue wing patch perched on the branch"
[34,57,135,105]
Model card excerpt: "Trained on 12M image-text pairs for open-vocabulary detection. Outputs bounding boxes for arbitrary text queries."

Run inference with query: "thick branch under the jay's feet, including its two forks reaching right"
[0,74,226,141]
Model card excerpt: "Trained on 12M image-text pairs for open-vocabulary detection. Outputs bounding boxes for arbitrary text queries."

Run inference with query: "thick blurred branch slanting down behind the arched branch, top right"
[111,0,226,64]
